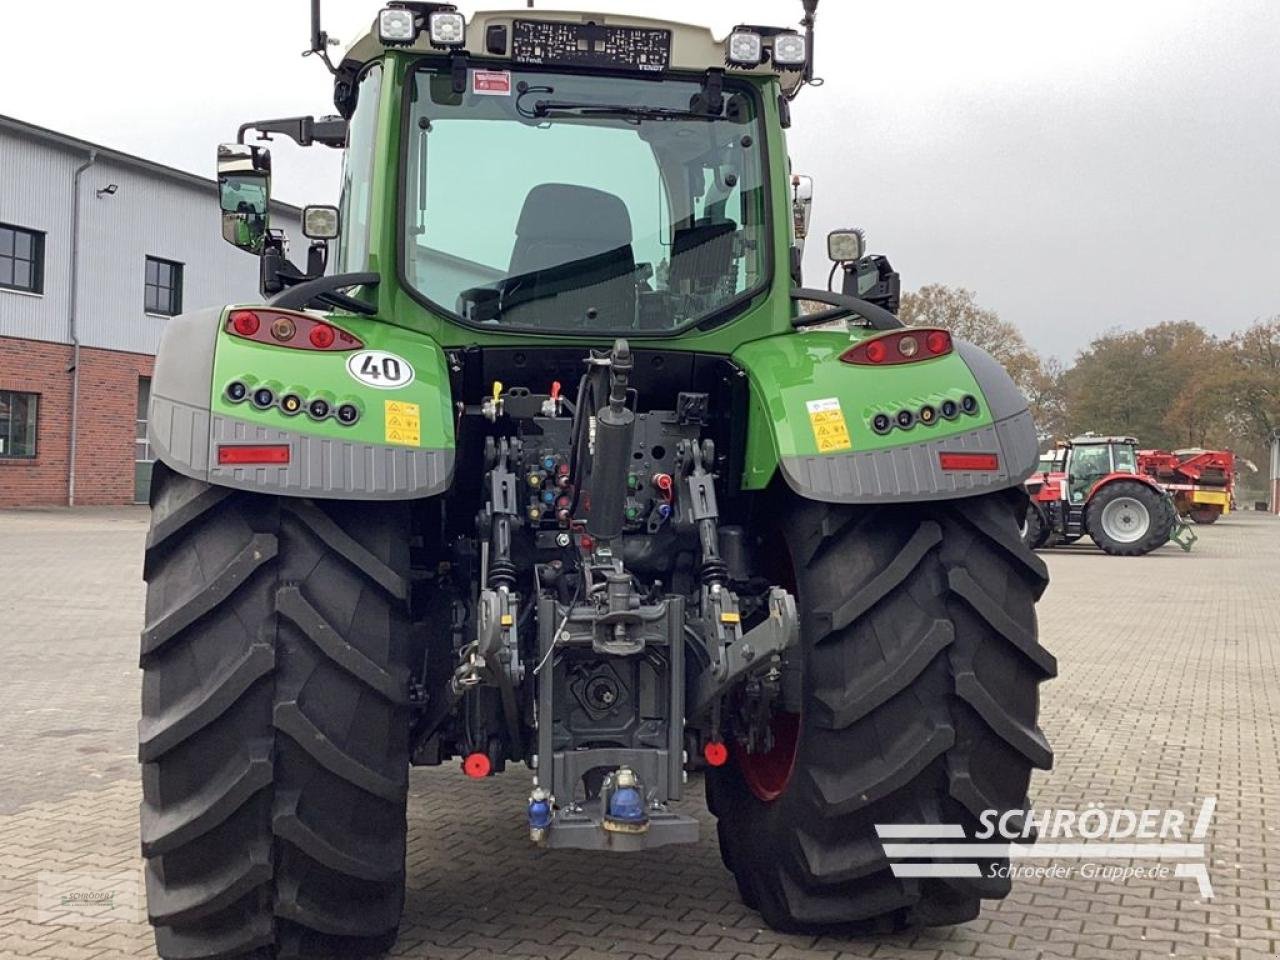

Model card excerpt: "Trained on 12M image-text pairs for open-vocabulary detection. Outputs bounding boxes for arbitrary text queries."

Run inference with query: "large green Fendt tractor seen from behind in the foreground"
[140,0,1056,957]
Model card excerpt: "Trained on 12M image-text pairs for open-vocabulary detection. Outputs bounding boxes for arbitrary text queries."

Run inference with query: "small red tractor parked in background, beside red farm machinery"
[1023,434,1196,557]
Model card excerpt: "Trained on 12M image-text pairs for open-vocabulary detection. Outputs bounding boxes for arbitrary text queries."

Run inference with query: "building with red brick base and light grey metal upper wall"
[0,116,301,507]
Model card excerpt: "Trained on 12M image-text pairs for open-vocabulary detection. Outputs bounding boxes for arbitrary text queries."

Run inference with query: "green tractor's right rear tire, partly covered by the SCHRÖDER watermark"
[708,490,1057,933]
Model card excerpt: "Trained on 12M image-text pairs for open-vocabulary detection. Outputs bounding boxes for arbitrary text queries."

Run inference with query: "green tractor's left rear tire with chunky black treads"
[138,463,408,959]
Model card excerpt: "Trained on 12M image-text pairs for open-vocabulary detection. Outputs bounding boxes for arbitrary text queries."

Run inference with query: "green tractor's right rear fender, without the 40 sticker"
[733,330,1039,503]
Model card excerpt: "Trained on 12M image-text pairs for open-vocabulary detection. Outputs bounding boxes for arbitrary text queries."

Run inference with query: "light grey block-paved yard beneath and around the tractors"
[0,511,1280,960]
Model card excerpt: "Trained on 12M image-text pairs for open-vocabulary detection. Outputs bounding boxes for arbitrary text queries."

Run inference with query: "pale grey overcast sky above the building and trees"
[0,0,1280,360]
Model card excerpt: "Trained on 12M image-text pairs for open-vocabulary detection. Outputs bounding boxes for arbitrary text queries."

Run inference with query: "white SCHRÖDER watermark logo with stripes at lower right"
[876,796,1217,900]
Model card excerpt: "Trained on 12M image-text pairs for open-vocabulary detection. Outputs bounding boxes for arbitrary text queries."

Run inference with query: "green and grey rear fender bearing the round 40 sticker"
[147,307,453,500]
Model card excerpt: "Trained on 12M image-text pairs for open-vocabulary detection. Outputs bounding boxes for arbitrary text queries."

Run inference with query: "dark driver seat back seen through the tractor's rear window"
[503,183,636,329]
